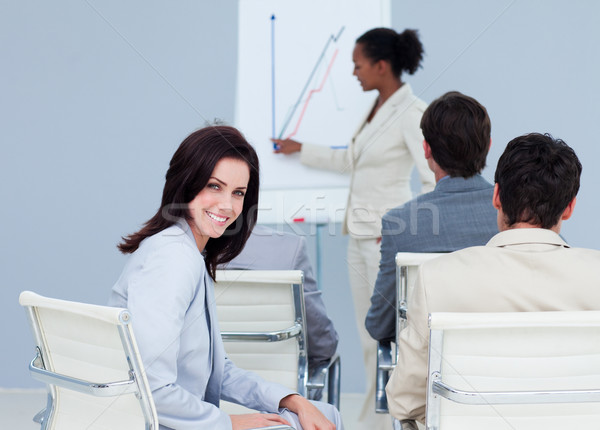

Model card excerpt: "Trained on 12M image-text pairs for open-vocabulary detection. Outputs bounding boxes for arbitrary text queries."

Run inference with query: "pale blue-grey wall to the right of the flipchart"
[392,0,600,248]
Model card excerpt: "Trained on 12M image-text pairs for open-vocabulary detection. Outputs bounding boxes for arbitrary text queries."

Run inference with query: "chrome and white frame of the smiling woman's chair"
[20,291,158,430]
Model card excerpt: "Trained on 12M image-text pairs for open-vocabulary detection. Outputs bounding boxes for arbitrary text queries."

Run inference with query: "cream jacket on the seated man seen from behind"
[386,228,600,421]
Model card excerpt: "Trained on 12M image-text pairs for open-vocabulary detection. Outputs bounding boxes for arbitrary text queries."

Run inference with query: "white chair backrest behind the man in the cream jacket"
[427,311,600,430]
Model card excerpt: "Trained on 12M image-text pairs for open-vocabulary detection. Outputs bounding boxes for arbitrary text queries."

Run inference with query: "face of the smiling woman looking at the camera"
[188,158,250,251]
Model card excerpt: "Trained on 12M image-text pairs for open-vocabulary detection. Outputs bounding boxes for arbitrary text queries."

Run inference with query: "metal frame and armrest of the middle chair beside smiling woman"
[216,269,341,410]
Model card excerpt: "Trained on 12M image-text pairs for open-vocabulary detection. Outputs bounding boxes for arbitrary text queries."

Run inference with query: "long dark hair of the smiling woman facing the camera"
[117,125,259,279]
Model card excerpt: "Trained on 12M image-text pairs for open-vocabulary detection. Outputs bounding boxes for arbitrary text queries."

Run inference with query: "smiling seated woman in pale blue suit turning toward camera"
[109,126,342,430]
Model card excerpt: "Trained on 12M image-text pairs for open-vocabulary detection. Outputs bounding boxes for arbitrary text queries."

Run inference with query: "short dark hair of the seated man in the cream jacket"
[494,133,581,229]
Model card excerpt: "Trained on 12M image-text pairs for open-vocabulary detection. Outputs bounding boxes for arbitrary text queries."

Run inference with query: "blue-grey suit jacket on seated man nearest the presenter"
[365,175,498,340]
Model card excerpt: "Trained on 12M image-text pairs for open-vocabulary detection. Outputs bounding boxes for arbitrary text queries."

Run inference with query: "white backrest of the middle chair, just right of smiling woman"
[215,270,308,412]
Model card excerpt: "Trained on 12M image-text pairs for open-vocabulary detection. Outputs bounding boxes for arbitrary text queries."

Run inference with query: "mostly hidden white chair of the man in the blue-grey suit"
[375,252,443,414]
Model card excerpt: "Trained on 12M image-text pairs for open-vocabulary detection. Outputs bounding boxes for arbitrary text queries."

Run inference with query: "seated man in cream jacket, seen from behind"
[386,133,600,421]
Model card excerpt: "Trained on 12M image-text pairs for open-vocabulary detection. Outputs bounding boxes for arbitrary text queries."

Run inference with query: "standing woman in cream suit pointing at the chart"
[274,28,435,428]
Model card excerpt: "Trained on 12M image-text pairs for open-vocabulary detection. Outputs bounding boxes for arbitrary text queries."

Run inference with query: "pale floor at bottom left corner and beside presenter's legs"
[0,389,363,430]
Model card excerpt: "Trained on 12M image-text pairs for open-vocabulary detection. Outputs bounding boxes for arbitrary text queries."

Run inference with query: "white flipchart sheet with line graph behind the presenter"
[235,0,391,189]
